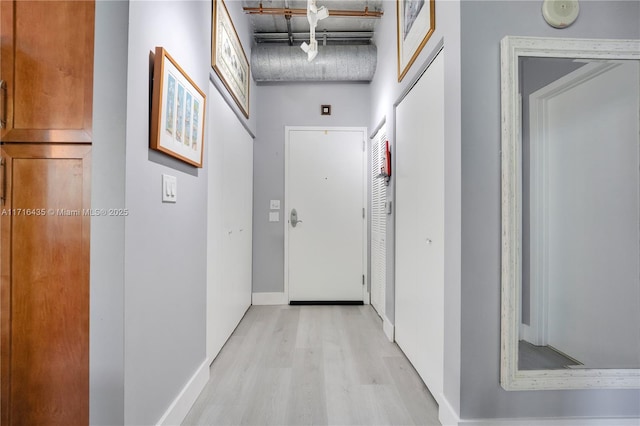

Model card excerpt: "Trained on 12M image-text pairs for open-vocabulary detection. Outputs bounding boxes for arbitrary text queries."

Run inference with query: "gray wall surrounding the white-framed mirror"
[460,1,640,418]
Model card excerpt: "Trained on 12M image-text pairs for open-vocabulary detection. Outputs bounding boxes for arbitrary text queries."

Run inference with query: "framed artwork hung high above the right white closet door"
[396,0,436,82]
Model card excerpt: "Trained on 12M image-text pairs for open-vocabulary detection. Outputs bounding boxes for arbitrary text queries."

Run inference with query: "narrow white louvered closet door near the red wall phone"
[371,126,387,317]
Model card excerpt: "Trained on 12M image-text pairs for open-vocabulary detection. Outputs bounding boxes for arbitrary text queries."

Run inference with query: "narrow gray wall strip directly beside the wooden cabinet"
[89,1,129,425]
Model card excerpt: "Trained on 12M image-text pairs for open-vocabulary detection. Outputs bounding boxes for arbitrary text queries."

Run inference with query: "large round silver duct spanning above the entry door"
[251,44,377,82]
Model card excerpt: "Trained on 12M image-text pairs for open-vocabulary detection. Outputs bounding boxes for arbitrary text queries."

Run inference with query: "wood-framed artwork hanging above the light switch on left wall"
[149,47,206,167]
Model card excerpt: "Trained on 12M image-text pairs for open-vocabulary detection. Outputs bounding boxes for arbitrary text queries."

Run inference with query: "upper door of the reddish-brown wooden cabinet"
[0,1,95,143]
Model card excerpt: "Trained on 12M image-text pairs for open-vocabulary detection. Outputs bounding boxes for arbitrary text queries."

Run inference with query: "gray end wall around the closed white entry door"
[253,83,369,293]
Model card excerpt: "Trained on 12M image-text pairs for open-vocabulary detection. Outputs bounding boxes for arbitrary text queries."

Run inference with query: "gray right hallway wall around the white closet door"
[369,0,461,412]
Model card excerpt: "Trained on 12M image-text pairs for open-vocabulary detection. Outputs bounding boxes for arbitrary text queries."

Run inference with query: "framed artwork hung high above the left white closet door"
[211,0,250,118]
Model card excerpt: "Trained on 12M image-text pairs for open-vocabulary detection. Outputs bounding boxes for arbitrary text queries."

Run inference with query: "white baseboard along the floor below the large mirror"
[460,417,640,426]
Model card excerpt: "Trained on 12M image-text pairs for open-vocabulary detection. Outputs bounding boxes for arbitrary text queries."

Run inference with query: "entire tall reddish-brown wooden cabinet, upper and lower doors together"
[0,0,94,426]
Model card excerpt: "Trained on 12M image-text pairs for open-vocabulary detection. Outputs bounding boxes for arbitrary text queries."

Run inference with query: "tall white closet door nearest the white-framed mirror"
[394,52,445,401]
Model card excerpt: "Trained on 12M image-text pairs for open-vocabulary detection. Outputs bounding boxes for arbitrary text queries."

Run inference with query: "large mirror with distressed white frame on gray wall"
[500,36,640,390]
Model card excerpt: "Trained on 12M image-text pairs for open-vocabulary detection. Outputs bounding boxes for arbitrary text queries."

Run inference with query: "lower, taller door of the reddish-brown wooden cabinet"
[0,144,91,426]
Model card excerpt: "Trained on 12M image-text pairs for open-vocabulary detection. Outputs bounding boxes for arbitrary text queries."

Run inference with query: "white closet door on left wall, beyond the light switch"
[205,84,253,360]
